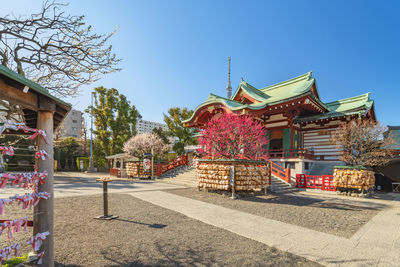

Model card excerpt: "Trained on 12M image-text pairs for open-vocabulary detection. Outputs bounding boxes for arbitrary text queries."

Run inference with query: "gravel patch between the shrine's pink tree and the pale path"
[168,188,384,238]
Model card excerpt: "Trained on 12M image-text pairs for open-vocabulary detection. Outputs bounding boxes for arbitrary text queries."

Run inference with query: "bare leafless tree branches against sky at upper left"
[0,0,121,96]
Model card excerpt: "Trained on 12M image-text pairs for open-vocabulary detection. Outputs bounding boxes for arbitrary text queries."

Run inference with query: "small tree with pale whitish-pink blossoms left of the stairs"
[124,133,171,159]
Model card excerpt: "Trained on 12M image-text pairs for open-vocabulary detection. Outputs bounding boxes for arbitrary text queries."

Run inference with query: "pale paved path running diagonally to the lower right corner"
[130,191,400,266]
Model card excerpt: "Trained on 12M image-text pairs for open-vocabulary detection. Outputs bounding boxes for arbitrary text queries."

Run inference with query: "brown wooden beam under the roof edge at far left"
[0,79,38,111]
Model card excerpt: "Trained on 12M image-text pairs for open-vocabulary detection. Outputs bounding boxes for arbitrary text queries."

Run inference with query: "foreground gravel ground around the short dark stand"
[1,194,320,267]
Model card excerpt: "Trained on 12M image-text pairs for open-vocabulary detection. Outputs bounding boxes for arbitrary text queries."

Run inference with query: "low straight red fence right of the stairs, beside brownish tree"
[296,174,336,191]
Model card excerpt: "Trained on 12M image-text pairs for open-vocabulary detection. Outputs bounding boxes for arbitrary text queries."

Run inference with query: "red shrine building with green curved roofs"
[184,72,376,179]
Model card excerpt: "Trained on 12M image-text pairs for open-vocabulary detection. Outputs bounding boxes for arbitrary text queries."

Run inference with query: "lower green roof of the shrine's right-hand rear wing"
[295,93,374,122]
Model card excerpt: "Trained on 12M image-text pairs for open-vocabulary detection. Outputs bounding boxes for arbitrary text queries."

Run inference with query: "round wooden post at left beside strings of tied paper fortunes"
[33,110,55,267]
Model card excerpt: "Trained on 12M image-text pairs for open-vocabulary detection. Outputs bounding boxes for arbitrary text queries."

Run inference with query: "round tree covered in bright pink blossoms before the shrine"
[198,114,268,159]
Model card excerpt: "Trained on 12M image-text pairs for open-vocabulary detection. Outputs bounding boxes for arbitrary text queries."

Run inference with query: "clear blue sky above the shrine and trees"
[0,0,400,125]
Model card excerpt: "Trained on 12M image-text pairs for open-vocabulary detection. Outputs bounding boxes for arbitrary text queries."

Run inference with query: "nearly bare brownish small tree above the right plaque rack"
[332,119,394,167]
